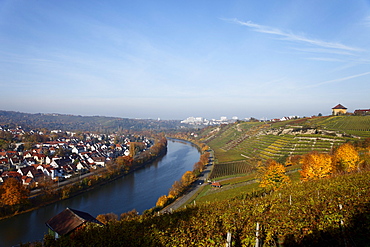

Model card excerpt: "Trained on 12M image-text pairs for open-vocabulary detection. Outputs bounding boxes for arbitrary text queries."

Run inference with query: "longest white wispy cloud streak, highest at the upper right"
[223,19,361,51]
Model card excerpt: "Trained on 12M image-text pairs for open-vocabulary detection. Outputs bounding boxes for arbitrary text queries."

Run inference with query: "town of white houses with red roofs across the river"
[0,126,153,189]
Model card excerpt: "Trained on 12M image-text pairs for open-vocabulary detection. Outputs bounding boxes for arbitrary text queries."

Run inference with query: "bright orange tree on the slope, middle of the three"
[299,151,334,181]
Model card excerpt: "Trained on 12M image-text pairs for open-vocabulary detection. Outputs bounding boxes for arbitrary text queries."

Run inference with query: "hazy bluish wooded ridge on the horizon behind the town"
[0,111,184,132]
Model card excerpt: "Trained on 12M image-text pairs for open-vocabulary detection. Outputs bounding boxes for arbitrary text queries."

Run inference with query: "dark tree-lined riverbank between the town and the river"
[0,138,167,220]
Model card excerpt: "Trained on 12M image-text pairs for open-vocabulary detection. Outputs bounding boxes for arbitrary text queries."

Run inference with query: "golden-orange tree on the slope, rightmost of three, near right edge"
[334,142,360,172]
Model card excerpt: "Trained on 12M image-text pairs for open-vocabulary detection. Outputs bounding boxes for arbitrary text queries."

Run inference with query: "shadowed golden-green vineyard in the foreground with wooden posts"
[40,172,370,247]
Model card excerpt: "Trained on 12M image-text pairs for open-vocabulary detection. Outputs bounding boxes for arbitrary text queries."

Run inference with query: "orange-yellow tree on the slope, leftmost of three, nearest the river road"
[259,160,291,190]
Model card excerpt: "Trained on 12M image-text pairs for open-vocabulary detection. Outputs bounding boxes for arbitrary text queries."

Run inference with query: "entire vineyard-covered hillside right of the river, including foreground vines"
[24,116,370,246]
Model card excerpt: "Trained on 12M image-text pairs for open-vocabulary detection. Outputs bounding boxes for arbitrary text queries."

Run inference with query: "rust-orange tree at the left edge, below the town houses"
[1,178,30,206]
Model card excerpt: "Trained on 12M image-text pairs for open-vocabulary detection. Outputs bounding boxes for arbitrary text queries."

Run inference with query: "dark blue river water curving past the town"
[0,140,200,247]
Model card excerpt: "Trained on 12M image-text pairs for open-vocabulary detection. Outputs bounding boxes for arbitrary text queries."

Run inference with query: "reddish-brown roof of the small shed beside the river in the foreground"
[45,208,104,235]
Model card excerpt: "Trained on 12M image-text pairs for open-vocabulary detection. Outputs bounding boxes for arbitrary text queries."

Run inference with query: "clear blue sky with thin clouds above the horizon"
[0,0,370,119]
